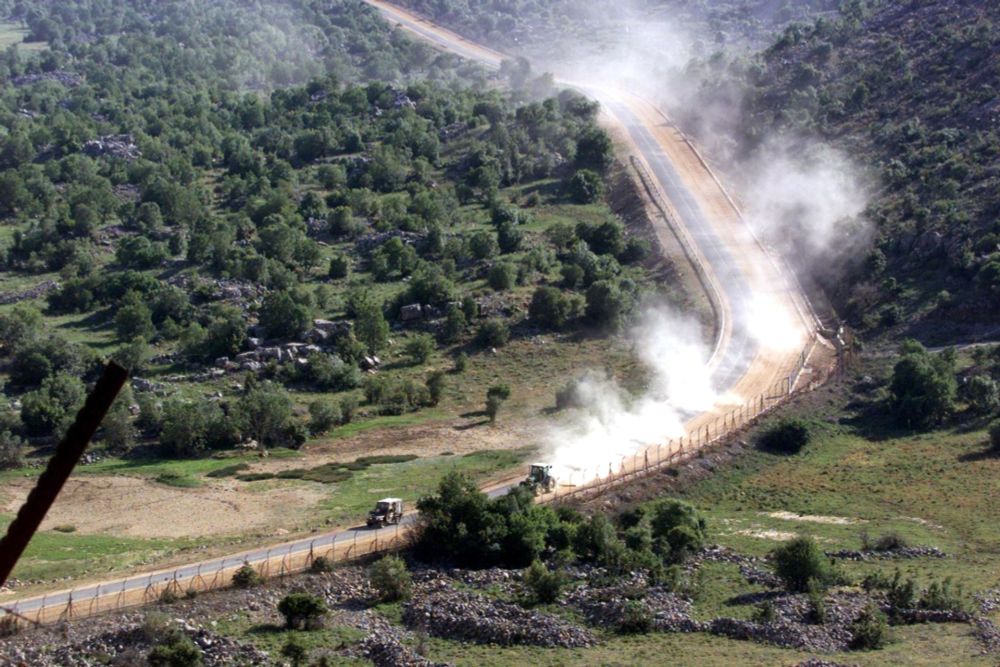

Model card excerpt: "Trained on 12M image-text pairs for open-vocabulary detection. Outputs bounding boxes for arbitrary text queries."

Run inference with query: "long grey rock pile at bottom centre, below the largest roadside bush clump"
[403,581,596,648]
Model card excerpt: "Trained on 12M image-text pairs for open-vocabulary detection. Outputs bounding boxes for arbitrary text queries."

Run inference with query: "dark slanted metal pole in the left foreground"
[0,361,128,586]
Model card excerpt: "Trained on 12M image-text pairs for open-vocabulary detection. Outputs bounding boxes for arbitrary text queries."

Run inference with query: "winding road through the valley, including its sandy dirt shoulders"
[3,0,815,620]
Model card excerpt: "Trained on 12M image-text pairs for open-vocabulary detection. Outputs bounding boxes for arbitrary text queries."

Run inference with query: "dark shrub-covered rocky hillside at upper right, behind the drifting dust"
[687,0,1000,339]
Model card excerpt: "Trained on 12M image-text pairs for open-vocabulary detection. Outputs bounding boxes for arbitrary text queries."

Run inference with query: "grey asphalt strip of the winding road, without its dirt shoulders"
[3,3,772,613]
